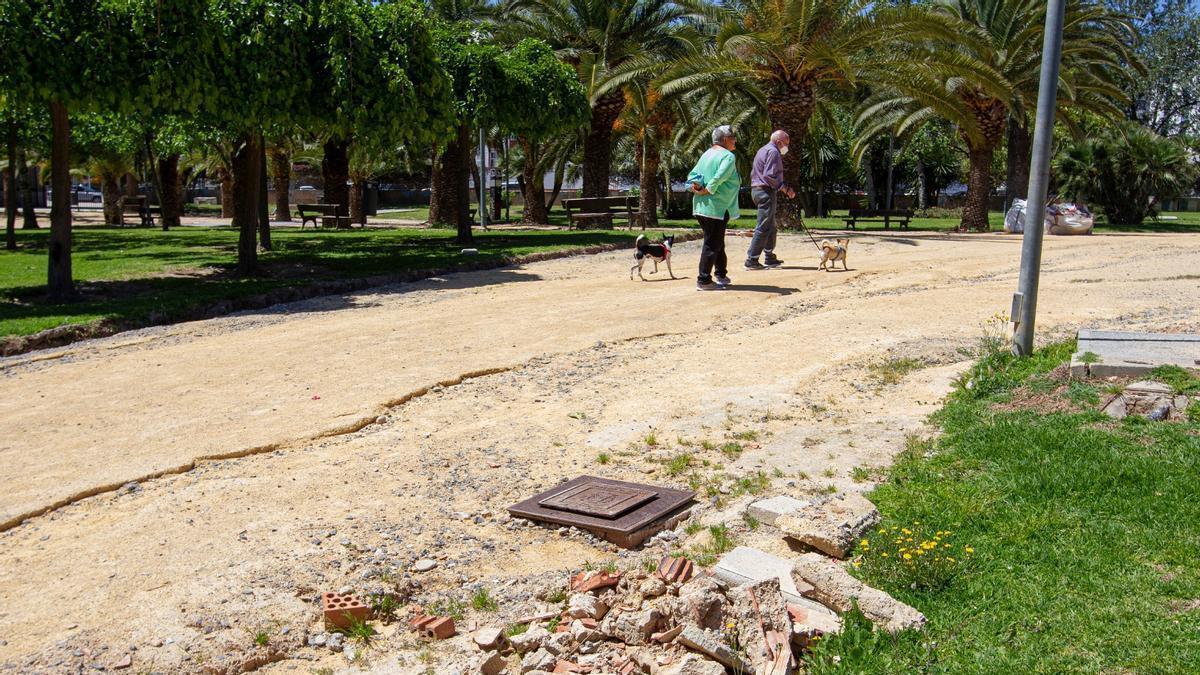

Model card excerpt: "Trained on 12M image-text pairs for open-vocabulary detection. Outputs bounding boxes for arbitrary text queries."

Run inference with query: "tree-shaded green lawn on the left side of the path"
[0,227,635,336]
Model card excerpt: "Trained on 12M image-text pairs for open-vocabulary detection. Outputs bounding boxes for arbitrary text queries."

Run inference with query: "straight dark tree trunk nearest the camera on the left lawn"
[46,101,74,296]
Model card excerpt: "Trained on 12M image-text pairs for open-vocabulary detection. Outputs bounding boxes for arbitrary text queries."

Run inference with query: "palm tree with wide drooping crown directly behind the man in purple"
[664,0,955,225]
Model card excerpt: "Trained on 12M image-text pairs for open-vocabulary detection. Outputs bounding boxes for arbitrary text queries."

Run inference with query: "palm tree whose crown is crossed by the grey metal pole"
[859,0,1136,231]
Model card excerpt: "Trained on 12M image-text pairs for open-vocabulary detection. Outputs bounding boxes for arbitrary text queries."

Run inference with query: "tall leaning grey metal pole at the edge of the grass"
[1012,0,1066,357]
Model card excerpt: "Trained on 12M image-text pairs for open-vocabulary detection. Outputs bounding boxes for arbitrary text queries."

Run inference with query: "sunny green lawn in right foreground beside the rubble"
[810,344,1200,674]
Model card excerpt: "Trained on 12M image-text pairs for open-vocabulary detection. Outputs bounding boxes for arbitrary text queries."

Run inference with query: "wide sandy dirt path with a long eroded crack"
[0,229,1200,671]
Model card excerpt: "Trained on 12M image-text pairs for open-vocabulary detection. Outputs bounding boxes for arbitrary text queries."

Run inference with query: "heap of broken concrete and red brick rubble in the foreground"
[316,487,925,675]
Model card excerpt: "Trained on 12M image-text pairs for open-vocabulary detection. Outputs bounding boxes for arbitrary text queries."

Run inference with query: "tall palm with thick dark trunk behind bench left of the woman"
[499,0,695,197]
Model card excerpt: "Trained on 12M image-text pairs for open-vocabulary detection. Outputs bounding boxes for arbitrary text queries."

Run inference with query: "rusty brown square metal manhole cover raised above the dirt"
[509,476,696,549]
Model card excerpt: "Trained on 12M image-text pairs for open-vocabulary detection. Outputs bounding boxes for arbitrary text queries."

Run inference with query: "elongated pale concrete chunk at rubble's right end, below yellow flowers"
[794,554,925,633]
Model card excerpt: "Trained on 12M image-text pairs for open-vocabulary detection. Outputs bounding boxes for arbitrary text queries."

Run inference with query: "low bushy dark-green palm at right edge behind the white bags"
[1054,124,1196,225]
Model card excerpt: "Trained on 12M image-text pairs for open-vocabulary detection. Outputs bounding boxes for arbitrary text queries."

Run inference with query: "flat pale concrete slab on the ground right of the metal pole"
[1070,330,1200,377]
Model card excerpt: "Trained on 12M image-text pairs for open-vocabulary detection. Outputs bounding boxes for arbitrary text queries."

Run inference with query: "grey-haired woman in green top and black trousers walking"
[688,125,742,291]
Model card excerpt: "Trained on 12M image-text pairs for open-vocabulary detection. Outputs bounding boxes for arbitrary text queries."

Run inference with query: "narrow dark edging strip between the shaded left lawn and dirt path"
[0,231,703,357]
